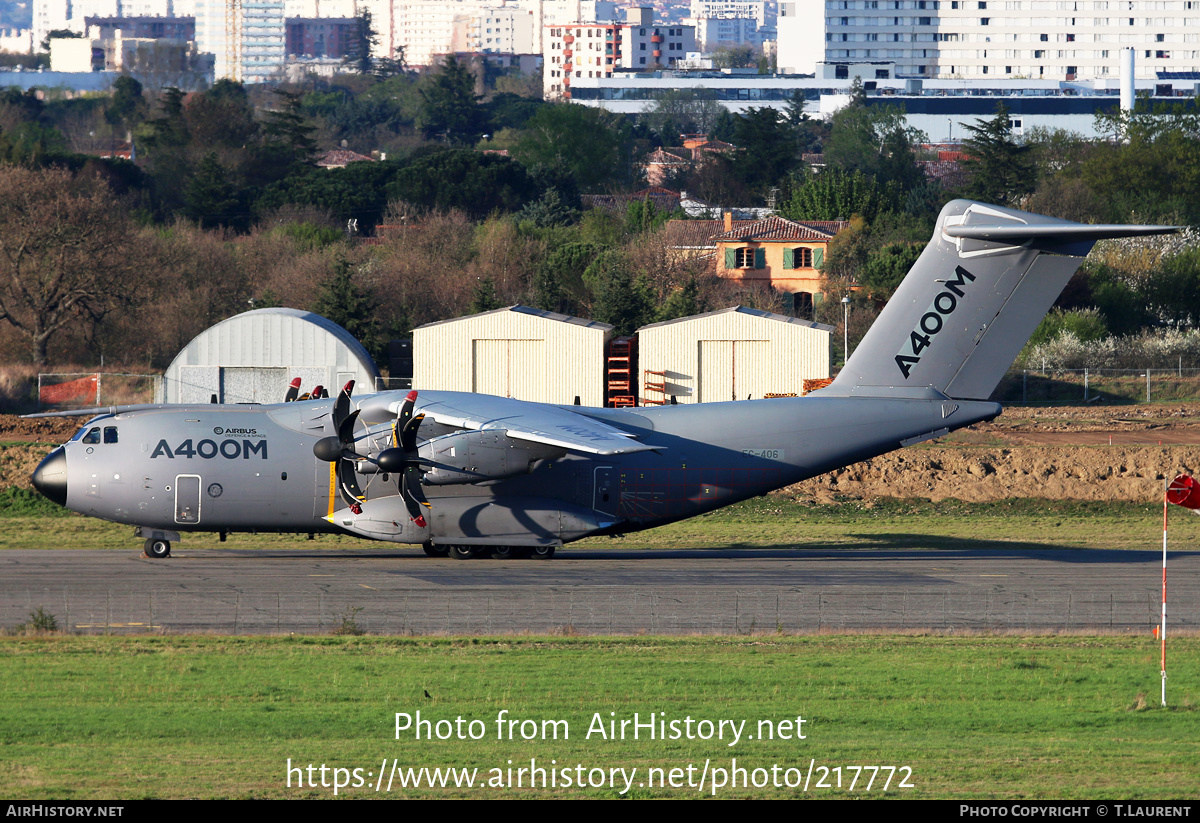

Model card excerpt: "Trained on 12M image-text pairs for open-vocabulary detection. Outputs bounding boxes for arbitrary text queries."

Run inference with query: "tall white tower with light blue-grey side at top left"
[196,0,286,83]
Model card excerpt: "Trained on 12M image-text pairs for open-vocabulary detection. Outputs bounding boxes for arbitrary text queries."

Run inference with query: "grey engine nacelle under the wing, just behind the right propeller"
[419,429,566,486]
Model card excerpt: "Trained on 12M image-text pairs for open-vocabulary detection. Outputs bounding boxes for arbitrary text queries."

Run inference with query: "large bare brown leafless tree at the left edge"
[0,166,144,367]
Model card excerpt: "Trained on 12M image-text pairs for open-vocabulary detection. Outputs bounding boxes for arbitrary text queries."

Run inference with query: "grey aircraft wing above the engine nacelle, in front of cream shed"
[392,391,658,455]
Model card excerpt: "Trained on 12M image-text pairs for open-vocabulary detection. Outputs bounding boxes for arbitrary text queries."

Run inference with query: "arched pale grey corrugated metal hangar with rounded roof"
[164,308,379,403]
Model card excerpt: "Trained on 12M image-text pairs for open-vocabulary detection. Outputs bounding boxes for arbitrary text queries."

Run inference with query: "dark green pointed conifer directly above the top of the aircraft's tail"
[962,103,1037,205]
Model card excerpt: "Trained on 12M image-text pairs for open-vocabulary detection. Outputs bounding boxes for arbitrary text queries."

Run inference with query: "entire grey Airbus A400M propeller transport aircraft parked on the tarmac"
[25,200,1174,558]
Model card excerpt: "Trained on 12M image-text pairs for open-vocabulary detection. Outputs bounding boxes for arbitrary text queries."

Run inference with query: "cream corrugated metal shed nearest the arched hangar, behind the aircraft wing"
[413,306,612,406]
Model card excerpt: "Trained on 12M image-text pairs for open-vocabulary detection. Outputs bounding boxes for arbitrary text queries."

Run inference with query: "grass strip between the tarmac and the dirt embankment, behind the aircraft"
[0,489,1200,552]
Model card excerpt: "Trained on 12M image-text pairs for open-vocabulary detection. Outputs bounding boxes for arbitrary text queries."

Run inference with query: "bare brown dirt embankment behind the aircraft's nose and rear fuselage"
[7,404,1200,501]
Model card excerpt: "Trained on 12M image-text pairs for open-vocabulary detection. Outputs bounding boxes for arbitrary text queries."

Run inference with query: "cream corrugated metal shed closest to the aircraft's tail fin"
[637,306,833,403]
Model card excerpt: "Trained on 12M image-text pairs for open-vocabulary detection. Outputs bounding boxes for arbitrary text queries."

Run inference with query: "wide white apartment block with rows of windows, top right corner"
[779,0,1200,80]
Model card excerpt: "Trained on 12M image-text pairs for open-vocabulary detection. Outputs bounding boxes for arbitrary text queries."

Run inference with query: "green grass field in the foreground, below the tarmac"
[0,636,1200,800]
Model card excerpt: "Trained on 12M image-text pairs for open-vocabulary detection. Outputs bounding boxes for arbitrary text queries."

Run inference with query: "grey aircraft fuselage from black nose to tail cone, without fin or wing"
[35,392,1000,554]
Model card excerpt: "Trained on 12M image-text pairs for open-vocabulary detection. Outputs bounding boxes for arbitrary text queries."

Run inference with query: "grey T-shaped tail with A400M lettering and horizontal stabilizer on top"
[822,200,1176,400]
